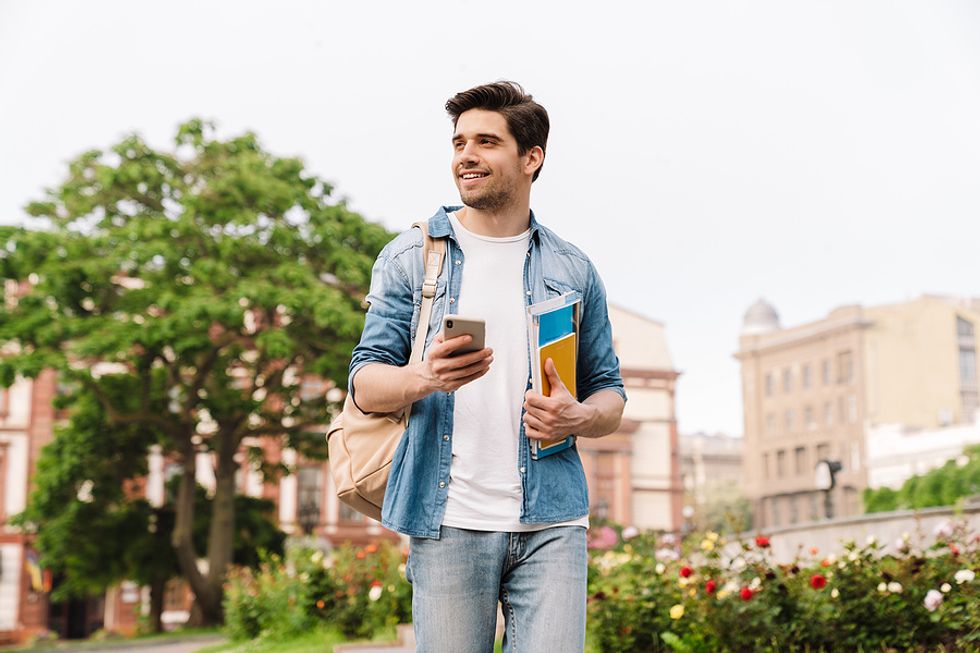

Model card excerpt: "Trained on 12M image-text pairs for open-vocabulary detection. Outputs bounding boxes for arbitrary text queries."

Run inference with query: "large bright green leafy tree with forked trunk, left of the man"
[0,120,390,623]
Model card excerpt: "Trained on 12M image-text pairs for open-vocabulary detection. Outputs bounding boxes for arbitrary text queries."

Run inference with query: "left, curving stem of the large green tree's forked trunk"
[173,437,222,626]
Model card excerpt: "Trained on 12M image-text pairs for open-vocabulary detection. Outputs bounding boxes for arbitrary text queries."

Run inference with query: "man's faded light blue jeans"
[407,526,588,653]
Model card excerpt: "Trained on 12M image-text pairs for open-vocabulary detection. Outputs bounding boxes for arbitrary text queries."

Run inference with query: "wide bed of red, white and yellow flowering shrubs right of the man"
[589,523,980,653]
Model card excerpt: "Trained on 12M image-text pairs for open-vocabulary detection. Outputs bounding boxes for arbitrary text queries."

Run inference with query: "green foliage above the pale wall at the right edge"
[864,446,980,512]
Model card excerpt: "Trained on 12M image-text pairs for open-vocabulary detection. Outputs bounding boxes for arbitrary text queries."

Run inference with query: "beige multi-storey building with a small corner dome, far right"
[736,296,980,527]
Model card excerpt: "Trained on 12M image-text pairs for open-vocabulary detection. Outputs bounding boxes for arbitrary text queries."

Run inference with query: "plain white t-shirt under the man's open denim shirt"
[442,213,588,531]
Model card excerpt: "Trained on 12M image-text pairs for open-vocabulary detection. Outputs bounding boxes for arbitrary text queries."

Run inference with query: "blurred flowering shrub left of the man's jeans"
[225,542,412,639]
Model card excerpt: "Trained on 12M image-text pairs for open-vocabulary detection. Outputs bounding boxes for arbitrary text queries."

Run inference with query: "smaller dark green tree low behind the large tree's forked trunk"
[13,376,285,631]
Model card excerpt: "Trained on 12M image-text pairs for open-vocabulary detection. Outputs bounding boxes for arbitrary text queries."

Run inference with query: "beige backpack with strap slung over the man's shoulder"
[327,222,446,521]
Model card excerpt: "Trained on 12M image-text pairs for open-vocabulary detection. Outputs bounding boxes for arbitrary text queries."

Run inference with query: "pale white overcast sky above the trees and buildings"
[0,0,980,434]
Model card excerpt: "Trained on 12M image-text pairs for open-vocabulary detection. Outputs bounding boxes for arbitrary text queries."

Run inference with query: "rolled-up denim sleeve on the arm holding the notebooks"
[578,263,626,401]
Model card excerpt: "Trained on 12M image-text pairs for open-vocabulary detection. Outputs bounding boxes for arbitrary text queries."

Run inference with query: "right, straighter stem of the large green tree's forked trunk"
[208,429,238,590]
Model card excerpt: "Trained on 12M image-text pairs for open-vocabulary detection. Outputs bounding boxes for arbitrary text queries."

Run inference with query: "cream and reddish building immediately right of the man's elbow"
[578,305,683,531]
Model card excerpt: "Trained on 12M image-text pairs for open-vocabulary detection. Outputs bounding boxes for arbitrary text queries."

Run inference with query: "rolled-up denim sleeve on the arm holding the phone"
[348,245,414,392]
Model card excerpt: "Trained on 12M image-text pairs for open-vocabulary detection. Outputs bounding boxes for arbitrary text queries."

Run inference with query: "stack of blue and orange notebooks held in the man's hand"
[527,292,582,460]
